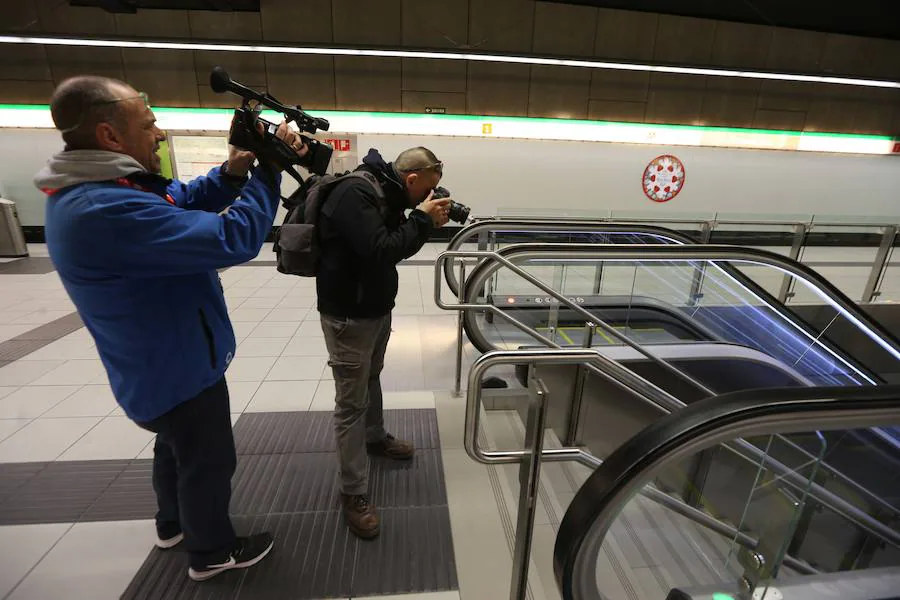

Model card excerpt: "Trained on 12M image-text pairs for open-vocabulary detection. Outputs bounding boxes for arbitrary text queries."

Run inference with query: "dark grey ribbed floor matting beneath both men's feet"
[0,409,457,600]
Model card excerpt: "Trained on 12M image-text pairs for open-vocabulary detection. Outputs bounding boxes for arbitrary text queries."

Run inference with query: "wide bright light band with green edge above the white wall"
[0,105,893,154]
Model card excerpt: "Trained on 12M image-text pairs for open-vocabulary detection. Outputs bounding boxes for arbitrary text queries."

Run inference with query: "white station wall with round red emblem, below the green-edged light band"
[0,128,900,227]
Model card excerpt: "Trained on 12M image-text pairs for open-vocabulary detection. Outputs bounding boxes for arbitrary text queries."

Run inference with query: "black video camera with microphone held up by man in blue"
[209,67,334,186]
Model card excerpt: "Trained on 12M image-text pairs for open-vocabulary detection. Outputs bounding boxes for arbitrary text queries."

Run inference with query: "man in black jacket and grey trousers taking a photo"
[316,148,449,538]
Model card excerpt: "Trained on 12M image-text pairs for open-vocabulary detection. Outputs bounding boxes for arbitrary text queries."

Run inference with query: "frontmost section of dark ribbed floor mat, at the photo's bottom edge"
[122,506,457,600]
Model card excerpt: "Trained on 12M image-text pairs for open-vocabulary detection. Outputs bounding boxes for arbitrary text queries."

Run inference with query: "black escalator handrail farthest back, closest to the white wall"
[444,219,697,296]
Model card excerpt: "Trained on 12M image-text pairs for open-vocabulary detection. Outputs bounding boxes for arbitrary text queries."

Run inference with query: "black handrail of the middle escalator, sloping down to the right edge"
[460,243,900,360]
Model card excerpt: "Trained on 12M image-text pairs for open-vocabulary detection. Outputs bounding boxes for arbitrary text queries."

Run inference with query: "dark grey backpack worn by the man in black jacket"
[274,171,384,277]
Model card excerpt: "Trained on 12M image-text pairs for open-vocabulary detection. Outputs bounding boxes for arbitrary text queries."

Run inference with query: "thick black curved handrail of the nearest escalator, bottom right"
[553,385,900,600]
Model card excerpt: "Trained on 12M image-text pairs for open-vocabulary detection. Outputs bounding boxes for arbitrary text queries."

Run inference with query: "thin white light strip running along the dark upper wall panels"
[0,35,900,89]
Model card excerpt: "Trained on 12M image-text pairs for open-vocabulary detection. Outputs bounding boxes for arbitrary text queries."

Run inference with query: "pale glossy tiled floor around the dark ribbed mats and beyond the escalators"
[0,244,900,600]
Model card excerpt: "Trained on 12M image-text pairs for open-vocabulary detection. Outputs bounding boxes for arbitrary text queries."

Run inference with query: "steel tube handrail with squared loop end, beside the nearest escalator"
[463,348,900,576]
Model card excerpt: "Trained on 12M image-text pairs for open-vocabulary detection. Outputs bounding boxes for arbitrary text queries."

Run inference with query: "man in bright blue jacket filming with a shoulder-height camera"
[35,77,306,581]
